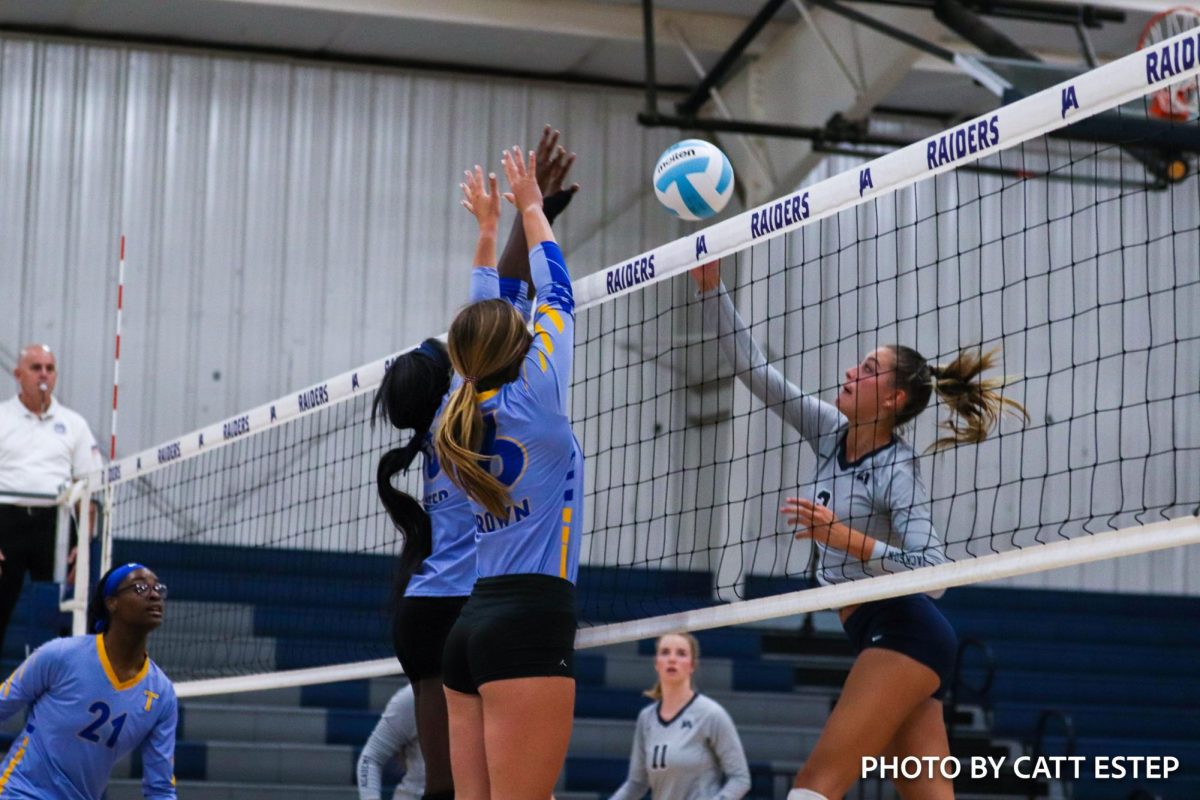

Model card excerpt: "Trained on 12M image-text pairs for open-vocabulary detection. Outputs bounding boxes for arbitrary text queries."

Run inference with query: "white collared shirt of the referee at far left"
[0,396,103,506]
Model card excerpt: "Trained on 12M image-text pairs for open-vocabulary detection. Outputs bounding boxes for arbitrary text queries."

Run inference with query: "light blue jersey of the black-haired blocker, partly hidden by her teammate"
[404,266,529,597]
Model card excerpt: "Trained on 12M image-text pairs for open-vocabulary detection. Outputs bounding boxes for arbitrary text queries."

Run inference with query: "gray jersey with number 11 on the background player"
[612,692,750,800]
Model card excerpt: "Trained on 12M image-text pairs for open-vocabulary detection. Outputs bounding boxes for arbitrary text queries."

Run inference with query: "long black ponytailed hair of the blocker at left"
[371,338,450,600]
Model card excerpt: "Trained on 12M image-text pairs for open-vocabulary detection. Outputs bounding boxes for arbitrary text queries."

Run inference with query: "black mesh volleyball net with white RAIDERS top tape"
[88,31,1200,694]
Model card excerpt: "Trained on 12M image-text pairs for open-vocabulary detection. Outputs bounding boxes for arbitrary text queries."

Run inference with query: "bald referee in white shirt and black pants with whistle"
[0,344,102,646]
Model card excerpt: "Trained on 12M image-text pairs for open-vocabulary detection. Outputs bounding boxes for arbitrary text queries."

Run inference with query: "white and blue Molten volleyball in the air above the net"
[654,139,733,222]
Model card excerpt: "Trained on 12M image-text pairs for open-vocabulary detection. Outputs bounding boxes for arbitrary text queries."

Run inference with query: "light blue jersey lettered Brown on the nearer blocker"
[472,241,583,583]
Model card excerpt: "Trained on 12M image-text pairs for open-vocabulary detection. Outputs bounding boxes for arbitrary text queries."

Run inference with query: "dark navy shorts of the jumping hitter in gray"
[842,595,959,699]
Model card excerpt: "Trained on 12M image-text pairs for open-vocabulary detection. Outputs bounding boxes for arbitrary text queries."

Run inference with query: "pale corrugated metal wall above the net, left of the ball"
[0,32,680,453]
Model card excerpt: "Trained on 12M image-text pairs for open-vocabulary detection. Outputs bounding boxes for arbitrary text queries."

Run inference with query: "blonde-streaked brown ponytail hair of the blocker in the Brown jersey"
[433,300,532,518]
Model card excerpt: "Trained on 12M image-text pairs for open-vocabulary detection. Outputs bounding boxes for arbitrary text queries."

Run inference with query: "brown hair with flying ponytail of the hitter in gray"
[889,344,1030,451]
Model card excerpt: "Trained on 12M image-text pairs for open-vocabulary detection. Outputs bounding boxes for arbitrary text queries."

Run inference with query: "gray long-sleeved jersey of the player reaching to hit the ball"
[701,285,946,584]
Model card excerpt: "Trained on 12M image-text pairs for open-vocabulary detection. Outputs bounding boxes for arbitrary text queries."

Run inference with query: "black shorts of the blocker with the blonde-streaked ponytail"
[442,575,576,694]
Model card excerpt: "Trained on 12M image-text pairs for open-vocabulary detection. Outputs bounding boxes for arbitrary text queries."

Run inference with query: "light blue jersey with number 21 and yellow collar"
[0,636,179,800]
